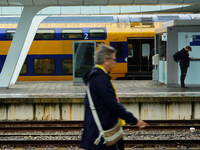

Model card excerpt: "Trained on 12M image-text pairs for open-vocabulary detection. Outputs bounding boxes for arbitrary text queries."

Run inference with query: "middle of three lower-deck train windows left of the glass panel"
[34,58,55,75]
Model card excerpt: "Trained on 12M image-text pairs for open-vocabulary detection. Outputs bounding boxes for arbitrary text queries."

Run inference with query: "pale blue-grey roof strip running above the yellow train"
[0,14,195,24]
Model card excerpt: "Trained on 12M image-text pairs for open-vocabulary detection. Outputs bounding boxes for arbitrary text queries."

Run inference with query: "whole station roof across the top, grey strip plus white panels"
[0,0,200,15]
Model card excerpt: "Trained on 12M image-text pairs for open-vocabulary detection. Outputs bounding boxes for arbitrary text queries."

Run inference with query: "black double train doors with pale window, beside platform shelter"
[127,38,154,77]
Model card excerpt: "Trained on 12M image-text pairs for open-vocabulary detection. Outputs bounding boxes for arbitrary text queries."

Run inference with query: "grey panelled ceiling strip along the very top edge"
[0,0,199,6]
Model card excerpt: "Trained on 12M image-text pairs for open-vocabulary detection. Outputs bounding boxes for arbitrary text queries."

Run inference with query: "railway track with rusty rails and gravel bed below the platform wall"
[0,120,200,148]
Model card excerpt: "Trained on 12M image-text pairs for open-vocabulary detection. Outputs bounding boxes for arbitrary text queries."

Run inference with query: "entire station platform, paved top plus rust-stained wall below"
[0,80,200,121]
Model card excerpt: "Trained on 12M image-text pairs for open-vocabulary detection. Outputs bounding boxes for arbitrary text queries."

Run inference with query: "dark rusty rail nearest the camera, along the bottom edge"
[0,140,200,149]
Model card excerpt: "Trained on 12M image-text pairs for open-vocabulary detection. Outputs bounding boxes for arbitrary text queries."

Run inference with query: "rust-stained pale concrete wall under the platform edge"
[0,102,200,121]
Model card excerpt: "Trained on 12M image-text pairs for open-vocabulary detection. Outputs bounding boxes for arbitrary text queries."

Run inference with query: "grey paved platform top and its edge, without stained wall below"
[0,80,200,103]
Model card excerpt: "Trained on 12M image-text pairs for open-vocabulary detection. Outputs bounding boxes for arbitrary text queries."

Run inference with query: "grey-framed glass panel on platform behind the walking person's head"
[73,41,96,85]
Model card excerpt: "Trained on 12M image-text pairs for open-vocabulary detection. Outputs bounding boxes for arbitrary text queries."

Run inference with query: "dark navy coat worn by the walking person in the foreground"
[80,68,137,150]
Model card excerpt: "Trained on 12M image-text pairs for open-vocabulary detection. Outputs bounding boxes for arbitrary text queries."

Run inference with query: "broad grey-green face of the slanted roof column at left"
[0,6,47,88]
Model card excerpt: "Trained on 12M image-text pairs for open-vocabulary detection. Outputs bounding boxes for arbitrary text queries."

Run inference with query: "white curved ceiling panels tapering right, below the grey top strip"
[0,5,200,16]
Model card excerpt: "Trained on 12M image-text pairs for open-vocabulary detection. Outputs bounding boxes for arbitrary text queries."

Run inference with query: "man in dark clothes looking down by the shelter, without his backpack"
[180,46,192,88]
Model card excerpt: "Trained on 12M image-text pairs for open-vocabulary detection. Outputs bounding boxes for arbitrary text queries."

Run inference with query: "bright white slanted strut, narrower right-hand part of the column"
[10,15,49,85]
